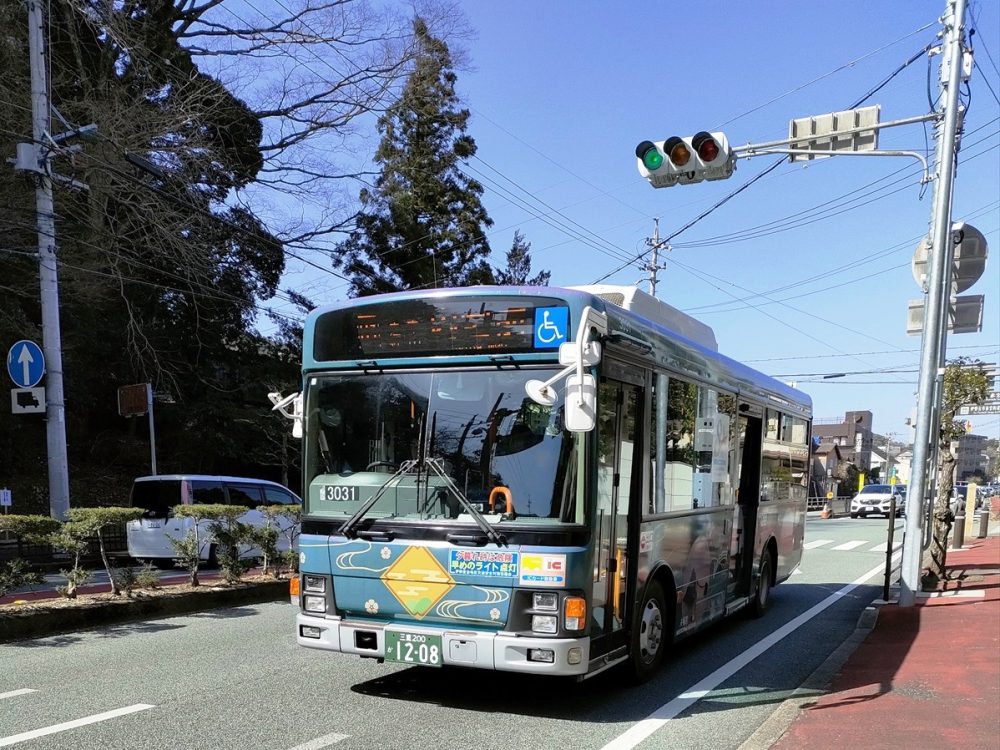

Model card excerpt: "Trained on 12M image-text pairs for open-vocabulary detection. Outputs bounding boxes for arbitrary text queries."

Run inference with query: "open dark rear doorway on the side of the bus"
[729,403,764,596]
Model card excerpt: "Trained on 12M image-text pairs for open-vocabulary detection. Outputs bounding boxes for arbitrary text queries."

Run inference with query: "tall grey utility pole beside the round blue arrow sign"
[28,0,69,519]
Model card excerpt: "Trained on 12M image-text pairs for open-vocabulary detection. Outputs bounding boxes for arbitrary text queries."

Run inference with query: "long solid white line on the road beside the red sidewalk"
[601,555,899,750]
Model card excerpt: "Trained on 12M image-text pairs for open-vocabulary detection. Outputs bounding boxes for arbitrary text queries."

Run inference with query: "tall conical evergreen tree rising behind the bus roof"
[337,18,493,296]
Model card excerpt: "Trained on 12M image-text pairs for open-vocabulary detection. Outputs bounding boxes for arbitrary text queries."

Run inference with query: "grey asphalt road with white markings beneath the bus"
[0,518,901,750]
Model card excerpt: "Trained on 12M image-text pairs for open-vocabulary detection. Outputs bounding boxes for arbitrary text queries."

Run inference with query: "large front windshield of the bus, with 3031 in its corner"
[305,369,583,524]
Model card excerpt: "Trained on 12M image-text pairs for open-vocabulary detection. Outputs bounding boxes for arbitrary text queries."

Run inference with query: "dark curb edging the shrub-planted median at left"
[0,579,288,643]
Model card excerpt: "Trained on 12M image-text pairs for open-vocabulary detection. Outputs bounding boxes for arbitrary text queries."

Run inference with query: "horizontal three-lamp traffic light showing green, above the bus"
[635,130,736,187]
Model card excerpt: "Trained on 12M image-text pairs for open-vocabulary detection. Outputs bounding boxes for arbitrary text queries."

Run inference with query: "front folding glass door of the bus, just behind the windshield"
[590,376,645,658]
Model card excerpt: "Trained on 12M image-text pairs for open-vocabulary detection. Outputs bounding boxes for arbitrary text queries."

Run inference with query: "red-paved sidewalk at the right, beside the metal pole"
[772,532,1000,750]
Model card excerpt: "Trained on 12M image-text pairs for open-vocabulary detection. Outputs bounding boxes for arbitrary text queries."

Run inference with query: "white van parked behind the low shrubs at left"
[126,474,302,561]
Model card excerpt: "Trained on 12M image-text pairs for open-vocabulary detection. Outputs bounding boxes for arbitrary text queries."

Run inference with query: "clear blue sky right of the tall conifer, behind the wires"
[262,0,1000,440]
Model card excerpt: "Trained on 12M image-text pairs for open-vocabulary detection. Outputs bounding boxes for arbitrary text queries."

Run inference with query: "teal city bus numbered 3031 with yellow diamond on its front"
[280,285,811,680]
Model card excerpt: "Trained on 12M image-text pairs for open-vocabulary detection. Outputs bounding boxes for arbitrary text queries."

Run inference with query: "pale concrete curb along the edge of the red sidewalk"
[738,599,887,750]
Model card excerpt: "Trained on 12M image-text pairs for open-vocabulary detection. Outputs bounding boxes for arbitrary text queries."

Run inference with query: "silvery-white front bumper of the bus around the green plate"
[295,612,590,676]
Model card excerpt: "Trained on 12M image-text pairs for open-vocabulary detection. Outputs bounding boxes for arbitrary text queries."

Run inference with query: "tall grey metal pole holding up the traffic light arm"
[899,0,965,607]
